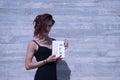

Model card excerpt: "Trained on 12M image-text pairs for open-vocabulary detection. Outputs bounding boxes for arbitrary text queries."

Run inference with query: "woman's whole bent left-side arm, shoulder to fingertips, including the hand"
[25,42,59,70]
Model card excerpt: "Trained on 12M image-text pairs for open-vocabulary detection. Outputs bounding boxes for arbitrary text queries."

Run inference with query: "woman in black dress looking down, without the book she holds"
[25,13,68,80]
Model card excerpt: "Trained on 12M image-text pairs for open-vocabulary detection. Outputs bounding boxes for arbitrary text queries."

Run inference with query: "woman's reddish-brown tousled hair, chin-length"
[33,13,55,36]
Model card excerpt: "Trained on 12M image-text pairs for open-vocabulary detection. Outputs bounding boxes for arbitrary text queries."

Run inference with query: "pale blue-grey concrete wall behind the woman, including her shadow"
[0,0,120,80]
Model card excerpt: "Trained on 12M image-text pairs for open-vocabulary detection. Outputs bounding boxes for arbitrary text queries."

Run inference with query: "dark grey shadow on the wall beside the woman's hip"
[57,60,71,80]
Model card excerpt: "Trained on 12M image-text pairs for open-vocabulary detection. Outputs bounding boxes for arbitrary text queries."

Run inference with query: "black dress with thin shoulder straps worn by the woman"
[33,40,57,80]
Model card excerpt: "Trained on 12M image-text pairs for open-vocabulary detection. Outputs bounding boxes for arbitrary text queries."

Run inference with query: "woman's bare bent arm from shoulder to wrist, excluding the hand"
[25,42,45,70]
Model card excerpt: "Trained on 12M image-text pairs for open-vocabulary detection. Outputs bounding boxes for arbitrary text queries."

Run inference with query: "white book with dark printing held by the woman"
[52,41,65,58]
